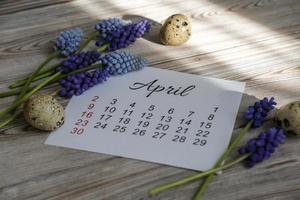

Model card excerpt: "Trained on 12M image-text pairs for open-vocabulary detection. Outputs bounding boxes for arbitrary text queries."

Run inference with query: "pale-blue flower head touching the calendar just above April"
[101,51,148,75]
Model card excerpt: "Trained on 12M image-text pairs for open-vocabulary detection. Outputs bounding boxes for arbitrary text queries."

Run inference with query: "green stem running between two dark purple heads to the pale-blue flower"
[0,64,102,98]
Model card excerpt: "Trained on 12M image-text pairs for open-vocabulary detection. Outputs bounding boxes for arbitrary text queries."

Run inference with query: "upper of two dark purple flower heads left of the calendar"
[56,51,101,74]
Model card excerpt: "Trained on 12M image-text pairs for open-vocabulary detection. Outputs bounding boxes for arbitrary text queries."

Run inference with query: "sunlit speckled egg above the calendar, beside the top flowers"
[160,14,192,45]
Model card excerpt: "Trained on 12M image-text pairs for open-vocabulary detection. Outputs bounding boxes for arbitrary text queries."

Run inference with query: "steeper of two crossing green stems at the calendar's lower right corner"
[193,121,253,200]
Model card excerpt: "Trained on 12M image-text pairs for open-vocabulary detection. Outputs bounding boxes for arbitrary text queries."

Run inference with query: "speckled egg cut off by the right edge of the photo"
[274,101,300,135]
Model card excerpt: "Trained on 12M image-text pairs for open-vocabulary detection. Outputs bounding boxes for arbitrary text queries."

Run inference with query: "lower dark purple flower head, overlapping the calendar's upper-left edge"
[59,69,109,98]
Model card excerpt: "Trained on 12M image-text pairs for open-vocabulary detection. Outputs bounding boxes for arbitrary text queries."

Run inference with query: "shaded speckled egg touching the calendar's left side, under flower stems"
[23,94,64,131]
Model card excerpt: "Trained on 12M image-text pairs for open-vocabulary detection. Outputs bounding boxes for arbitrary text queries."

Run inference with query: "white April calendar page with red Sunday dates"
[46,67,245,171]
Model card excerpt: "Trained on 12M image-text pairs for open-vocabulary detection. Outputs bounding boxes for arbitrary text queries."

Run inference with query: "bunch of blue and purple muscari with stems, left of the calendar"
[0,18,150,128]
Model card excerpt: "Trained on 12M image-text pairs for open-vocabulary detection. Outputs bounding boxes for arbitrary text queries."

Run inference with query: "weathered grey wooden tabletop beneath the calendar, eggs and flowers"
[0,0,300,200]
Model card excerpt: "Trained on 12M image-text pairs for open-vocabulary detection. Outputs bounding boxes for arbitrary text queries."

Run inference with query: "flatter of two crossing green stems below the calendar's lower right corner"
[148,154,249,196]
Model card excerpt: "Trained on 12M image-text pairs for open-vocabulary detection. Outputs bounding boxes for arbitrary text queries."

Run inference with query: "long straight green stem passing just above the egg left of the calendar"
[0,72,61,118]
